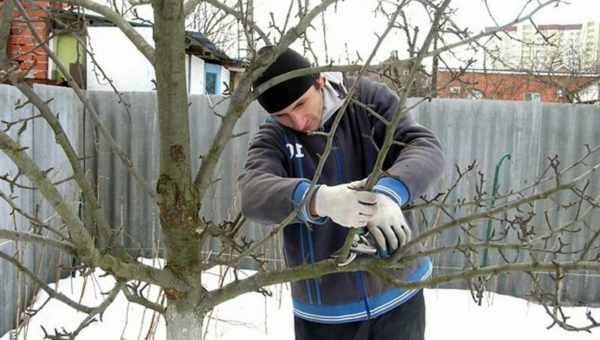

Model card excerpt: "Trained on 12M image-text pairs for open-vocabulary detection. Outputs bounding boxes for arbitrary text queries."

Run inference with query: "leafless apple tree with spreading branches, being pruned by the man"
[0,0,600,340]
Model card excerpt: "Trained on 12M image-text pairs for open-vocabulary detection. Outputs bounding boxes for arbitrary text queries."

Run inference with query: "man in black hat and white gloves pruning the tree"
[239,47,443,340]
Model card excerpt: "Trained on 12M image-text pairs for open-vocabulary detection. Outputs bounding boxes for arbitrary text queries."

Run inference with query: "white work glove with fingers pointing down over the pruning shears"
[367,193,411,256]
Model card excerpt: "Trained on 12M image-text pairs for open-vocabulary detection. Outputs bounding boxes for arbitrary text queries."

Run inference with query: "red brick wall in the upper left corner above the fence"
[8,1,55,80]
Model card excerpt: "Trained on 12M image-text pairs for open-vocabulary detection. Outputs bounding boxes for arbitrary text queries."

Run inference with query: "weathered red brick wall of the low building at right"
[438,71,595,102]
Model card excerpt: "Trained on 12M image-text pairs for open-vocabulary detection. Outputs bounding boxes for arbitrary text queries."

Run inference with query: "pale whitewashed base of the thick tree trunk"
[165,302,204,340]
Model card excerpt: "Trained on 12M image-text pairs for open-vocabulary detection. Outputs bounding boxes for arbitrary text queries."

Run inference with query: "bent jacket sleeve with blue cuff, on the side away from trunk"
[360,80,445,206]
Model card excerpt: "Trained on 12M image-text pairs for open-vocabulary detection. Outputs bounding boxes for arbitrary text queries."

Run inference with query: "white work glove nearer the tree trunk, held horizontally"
[313,181,376,228]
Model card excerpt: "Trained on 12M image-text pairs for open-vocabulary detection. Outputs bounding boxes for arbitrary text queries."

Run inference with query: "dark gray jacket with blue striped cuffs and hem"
[239,75,444,323]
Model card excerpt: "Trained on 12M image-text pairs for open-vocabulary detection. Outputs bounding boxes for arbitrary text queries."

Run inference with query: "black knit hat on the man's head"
[253,46,315,113]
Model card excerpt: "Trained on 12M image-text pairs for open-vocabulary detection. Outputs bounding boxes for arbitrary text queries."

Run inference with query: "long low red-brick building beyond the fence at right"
[437,69,600,103]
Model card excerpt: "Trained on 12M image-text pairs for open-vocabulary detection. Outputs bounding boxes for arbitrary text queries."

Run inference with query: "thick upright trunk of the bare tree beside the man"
[152,0,204,340]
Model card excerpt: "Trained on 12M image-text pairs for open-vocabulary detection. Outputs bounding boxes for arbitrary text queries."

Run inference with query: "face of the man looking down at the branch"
[271,77,325,133]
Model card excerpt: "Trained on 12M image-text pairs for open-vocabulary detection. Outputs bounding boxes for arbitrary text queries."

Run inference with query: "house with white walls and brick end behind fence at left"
[4,1,243,94]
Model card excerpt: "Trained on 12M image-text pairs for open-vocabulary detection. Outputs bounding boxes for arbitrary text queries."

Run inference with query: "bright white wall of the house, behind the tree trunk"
[87,27,204,94]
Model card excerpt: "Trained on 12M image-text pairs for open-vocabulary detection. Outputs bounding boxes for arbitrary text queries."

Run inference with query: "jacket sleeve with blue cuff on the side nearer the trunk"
[238,123,326,224]
